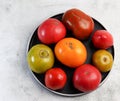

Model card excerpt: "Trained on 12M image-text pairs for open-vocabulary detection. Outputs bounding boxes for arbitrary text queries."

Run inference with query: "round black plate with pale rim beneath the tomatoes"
[27,13,114,96]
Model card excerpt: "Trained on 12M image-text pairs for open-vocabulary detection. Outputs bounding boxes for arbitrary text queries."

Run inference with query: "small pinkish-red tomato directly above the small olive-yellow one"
[92,30,113,49]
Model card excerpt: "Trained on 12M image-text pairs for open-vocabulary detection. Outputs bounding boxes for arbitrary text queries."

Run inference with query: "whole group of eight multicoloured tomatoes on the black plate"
[27,9,113,92]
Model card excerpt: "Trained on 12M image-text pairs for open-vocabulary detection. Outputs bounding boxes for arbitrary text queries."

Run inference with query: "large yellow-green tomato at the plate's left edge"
[27,44,54,73]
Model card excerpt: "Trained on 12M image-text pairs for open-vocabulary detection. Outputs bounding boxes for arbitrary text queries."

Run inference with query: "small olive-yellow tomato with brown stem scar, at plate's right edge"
[92,50,113,72]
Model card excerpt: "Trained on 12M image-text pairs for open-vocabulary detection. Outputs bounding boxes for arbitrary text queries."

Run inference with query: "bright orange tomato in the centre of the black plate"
[54,38,87,68]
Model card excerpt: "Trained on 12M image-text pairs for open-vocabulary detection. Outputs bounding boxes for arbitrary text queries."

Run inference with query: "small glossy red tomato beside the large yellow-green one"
[45,68,67,90]
